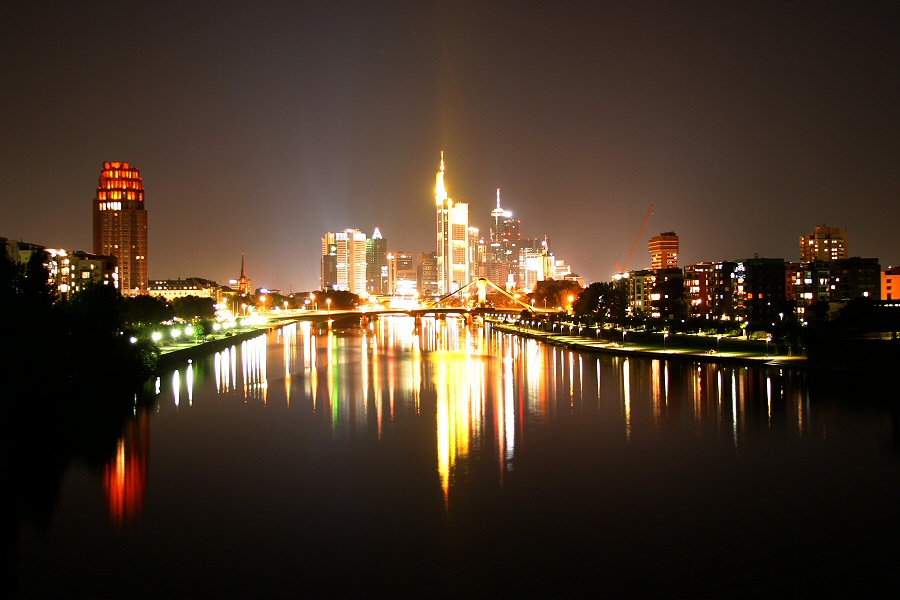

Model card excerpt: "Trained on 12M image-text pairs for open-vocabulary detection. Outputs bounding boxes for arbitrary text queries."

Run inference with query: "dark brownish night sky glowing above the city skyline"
[0,1,900,292]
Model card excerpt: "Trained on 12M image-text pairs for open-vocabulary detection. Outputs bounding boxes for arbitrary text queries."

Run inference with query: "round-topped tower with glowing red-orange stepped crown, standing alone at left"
[94,162,148,294]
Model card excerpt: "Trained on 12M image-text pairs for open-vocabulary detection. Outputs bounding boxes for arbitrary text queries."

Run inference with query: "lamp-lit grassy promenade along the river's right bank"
[491,322,807,368]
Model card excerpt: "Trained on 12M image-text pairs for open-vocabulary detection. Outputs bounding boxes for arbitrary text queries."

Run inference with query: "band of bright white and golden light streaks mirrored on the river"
[137,317,832,507]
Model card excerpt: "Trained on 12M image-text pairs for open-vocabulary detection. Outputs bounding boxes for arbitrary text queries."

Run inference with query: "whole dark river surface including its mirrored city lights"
[13,318,900,598]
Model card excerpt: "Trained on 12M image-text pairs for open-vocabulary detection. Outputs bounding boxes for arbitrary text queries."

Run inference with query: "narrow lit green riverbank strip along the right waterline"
[491,322,807,368]
